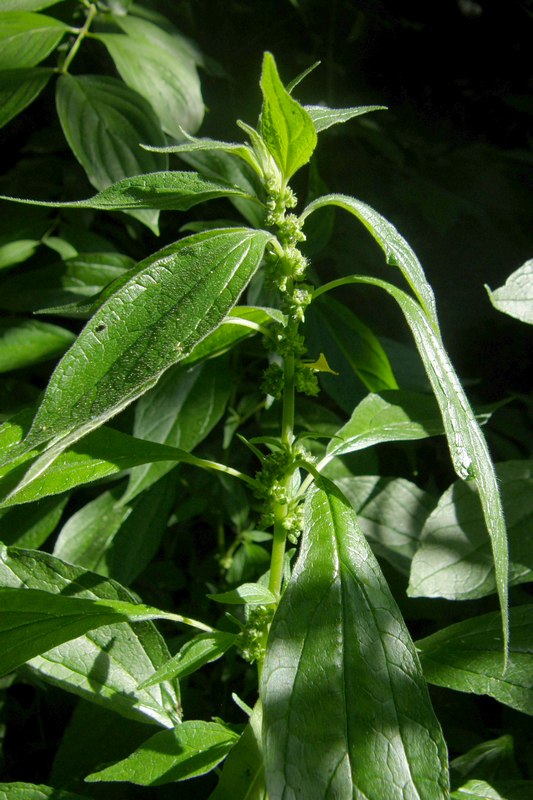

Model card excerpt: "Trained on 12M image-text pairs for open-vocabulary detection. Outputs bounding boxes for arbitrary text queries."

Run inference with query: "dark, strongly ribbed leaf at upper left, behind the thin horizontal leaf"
[56,75,168,231]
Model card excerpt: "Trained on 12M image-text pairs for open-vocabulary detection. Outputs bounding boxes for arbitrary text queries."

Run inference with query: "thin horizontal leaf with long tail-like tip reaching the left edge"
[0,172,258,211]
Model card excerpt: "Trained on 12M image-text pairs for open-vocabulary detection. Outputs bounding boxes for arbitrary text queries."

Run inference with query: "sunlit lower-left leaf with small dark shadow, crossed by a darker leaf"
[0,548,180,728]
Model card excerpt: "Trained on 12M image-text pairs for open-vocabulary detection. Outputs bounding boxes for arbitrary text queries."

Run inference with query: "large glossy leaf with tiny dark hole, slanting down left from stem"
[2,228,271,494]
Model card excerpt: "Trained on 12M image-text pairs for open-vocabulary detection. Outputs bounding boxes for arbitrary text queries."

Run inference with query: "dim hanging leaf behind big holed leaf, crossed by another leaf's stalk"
[123,358,232,502]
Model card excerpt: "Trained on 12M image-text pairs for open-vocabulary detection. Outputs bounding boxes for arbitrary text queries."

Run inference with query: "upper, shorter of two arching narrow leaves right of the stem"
[300,194,439,326]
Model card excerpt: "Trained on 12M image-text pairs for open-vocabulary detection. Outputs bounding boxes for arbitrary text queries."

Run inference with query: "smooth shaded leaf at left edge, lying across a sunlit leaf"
[0,587,180,675]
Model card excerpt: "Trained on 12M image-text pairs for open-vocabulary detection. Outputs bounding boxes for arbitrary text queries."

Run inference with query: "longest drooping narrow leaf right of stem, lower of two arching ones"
[319,275,509,661]
